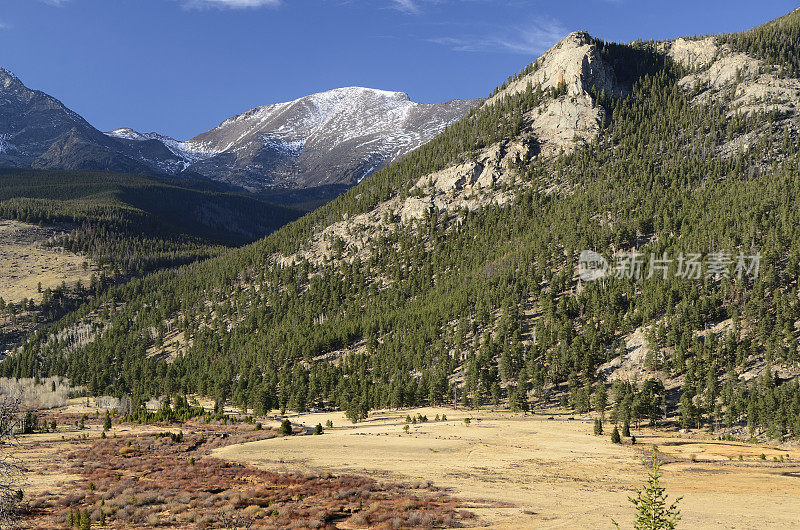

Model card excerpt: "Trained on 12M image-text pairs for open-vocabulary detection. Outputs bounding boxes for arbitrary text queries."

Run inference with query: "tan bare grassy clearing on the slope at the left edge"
[0,220,95,302]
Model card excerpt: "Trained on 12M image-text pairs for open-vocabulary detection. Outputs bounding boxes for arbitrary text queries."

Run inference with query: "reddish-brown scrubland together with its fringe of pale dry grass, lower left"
[12,399,475,529]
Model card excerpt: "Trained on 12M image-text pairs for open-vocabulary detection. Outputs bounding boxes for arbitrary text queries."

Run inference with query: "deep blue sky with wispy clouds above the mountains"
[0,0,798,139]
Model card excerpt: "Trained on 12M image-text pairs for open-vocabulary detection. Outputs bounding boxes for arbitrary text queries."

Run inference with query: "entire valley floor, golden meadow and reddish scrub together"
[14,398,800,529]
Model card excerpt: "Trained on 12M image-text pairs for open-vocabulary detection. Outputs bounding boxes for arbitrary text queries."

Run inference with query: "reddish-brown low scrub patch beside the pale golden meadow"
[21,425,472,528]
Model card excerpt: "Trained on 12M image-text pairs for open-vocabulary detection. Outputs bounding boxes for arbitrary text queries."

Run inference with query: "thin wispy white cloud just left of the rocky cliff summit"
[428,19,568,55]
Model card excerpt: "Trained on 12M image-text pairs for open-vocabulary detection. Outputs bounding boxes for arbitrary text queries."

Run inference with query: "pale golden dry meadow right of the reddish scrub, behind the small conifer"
[215,409,800,529]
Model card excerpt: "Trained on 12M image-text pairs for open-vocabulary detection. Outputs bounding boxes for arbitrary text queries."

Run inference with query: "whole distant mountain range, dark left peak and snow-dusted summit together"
[0,68,481,193]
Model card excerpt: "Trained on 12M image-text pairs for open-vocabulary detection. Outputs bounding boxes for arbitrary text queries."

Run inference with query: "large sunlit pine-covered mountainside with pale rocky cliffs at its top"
[2,13,800,439]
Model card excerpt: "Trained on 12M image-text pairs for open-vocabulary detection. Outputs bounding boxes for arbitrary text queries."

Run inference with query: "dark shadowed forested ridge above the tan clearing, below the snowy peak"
[0,169,300,274]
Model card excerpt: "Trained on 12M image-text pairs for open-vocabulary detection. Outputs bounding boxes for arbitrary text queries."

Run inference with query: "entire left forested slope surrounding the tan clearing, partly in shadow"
[0,169,301,354]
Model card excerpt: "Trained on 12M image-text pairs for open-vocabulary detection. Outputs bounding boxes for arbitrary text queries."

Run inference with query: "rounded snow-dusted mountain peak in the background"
[108,87,477,192]
